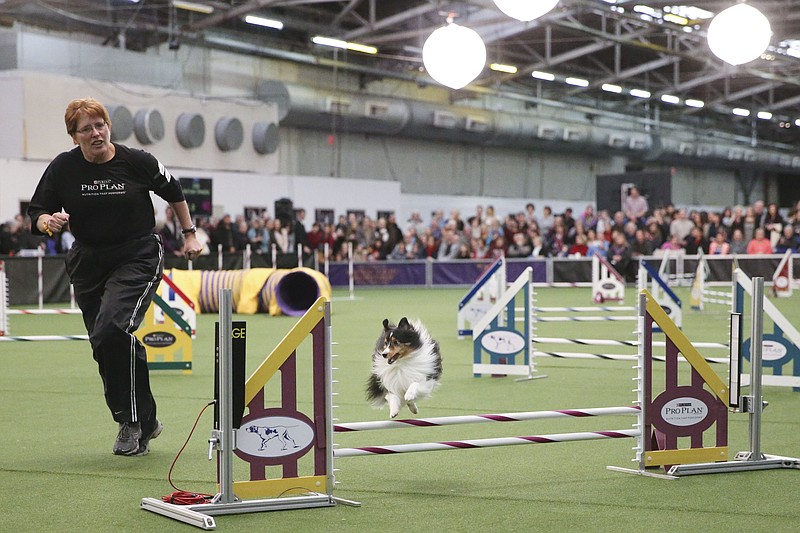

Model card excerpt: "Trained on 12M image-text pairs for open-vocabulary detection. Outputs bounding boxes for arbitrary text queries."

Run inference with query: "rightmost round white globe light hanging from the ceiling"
[708,4,772,65]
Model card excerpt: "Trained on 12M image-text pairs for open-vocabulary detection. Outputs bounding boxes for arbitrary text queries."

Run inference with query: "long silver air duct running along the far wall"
[256,80,800,174]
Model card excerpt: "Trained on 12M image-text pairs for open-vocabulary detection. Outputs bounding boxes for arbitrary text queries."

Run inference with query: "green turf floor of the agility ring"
[0,289,800,532]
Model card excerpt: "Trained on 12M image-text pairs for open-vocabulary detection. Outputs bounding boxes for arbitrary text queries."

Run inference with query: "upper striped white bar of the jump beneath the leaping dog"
[333,407,639,433]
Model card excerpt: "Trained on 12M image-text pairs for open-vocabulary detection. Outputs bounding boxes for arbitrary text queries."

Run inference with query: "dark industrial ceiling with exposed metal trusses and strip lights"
[0,0,800,146]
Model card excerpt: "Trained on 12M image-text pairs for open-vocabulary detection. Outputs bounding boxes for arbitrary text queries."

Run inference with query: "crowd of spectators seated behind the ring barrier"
[0,194,800,272]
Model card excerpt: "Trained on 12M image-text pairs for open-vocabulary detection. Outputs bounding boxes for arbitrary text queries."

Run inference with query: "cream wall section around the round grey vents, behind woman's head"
[0,71,278,173]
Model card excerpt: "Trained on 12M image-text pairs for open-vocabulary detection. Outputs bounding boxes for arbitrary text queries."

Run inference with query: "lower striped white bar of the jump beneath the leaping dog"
[333,429,642,458]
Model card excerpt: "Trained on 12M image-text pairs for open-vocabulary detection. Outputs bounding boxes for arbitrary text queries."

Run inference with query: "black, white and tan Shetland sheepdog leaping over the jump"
[367,317,442,418]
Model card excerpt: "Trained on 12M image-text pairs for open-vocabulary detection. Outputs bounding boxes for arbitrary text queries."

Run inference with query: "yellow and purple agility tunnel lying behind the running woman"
[164,267,331,316]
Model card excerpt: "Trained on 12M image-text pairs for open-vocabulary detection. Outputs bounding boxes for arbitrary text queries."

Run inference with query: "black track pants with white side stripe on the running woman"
[66,235,164,430]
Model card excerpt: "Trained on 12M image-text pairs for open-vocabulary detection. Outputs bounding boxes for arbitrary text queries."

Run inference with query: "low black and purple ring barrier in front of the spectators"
[0,249,800,306]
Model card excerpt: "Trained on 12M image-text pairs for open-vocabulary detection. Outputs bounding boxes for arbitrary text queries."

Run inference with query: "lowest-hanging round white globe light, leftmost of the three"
[422,24,486,89]
